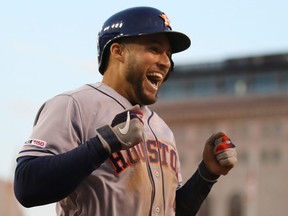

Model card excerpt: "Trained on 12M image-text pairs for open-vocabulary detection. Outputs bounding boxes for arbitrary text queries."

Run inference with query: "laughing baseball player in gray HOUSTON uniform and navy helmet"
[14,7,237,216]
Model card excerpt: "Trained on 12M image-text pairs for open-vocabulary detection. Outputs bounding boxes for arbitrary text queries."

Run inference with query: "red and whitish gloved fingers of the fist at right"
[214,135,237,166]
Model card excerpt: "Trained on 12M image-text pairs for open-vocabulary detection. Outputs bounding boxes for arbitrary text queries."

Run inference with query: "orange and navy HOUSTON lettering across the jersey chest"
[110,140,177,175]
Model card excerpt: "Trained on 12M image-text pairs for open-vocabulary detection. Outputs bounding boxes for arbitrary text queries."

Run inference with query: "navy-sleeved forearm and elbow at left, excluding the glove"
[14,137,109,207]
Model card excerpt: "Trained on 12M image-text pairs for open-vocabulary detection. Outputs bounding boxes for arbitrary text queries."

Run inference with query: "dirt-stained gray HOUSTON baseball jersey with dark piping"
[18,82,182,216]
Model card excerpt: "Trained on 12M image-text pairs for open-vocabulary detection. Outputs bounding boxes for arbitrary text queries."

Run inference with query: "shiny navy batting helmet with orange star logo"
[97,7,191,74]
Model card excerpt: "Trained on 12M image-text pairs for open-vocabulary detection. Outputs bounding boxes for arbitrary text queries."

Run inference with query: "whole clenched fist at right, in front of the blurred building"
[203,132,237,175]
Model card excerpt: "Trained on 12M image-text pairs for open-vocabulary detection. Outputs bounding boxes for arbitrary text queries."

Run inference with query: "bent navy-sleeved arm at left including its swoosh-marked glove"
[14,107,144,207]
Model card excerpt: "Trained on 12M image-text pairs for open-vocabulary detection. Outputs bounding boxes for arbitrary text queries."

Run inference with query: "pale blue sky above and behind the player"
[0,0,288,216]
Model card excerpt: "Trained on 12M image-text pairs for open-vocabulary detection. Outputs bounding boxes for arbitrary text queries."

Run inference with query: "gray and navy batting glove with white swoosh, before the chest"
[96,105,144,154]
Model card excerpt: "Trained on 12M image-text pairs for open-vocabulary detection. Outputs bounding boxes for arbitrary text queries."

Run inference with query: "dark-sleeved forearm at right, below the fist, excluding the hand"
[176,162,219,216]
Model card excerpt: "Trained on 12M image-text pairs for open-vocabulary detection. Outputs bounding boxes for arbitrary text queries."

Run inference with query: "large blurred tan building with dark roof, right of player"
[153,54,288,216]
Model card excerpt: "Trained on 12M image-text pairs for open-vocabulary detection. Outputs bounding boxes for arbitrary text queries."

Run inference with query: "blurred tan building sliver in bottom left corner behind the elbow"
[0,180,23,216]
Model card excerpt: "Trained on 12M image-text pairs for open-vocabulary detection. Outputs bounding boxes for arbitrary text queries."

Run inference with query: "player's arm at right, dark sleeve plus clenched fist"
[176,132,237,216]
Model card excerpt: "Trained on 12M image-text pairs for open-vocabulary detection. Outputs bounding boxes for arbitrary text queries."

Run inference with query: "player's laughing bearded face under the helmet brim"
[123,34,171,105]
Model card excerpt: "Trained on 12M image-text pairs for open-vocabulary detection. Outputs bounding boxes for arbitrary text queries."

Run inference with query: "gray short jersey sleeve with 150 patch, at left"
[18,94,83,158]
